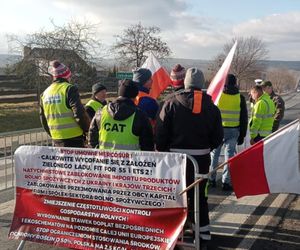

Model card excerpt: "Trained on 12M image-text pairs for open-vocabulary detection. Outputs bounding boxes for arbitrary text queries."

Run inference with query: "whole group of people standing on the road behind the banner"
[40,61,284,247]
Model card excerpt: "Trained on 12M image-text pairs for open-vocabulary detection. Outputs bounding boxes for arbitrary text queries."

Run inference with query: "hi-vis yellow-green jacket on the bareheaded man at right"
[250,93,275,139]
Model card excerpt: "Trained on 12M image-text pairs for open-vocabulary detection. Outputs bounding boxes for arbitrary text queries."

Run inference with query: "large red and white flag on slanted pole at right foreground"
[228,119,300,198]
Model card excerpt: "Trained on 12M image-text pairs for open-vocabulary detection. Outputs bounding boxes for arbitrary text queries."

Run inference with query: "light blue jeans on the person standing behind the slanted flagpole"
[210,128,240,184]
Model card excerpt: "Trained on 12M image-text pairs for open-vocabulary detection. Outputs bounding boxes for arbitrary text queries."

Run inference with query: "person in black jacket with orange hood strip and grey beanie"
[155,68,223,246]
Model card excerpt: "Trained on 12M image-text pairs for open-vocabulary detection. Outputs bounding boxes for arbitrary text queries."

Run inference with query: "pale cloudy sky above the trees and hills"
[0,0,300,61]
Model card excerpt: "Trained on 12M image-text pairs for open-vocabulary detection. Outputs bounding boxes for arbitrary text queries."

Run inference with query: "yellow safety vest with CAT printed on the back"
[99,105,140,150]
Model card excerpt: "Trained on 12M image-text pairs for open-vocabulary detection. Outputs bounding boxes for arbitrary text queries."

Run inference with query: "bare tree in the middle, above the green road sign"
[113,23,171,67]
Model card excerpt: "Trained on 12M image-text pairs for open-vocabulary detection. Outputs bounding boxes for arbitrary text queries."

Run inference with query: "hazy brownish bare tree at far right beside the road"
[266,68,297,93]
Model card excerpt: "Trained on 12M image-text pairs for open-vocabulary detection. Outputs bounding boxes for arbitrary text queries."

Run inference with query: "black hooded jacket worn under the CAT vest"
[88,97,154,151]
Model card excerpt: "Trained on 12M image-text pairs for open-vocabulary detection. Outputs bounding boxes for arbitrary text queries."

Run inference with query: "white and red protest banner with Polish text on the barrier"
[9,146,187,249]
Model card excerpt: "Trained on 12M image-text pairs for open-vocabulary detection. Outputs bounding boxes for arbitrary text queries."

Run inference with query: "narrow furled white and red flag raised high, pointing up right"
[207,41,237,105]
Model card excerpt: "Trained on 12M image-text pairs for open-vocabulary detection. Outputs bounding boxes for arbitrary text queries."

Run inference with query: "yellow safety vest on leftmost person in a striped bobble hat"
[41,82,83,139]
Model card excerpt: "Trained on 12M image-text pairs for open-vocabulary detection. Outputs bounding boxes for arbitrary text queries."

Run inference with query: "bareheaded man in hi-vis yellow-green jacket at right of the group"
[249,85,275,145]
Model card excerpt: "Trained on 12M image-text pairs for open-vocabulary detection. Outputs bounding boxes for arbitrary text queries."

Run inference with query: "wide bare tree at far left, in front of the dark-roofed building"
[9,21,101,88]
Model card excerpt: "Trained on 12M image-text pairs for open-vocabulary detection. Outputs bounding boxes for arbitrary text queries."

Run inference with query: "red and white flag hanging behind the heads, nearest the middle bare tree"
[141,52,172,99]
